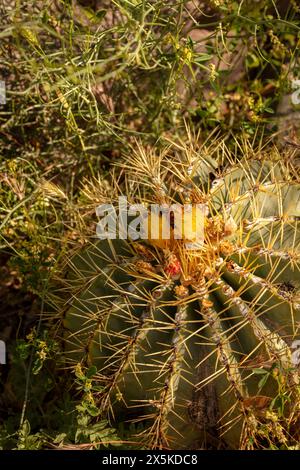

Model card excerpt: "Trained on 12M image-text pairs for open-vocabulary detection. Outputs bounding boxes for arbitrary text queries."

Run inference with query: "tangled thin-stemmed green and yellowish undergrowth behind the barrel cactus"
[0,0,300,448]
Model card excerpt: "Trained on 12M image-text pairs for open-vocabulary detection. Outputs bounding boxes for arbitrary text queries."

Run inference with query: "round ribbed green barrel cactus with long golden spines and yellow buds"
[52,134,300,448]
